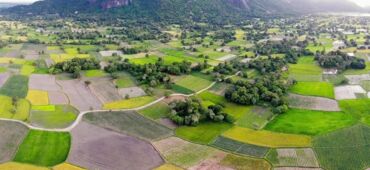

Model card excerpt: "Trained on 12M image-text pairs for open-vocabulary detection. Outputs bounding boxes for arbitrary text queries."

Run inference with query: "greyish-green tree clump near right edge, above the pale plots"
[315,51,366,71]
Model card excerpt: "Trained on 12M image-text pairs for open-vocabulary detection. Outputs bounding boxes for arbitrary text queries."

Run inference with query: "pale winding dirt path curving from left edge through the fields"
[0,72,239,132]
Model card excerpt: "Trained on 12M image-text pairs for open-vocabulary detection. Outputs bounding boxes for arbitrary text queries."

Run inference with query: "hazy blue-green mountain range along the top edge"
[2,0,365,21]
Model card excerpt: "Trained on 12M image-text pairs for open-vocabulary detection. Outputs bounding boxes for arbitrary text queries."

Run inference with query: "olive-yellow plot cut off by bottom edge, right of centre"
[220,154,271,170]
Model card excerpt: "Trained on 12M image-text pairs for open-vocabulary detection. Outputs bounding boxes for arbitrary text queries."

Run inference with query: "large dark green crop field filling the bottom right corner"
[313,125,370,170]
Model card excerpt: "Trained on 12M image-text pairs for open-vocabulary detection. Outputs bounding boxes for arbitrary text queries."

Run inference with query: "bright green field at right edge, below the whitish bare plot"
[339,99,370,125]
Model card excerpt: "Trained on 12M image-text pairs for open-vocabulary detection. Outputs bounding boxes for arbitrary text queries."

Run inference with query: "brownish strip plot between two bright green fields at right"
[289,94,340,111]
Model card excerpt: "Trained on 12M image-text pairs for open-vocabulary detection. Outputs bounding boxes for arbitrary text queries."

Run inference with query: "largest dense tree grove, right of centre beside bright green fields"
[225,73,294,114]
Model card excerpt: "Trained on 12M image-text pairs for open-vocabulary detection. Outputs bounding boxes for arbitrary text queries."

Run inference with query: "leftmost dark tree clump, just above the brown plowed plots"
[49,58,100,78]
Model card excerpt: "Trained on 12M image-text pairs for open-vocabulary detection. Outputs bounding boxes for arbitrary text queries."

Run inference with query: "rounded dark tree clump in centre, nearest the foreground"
[169,98,234,126]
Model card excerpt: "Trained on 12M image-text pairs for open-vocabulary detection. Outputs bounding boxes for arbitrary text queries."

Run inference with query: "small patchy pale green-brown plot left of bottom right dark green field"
[267,148,319,167]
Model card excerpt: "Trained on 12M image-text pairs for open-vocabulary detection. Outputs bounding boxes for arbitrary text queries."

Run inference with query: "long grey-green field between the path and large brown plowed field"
[83,112,173,140]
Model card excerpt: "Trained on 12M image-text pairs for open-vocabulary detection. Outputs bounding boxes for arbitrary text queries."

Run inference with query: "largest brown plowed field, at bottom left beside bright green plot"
[67,122,163,170]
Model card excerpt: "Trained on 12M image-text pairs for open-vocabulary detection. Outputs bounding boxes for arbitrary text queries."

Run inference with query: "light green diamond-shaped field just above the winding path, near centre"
[175,75,212,92]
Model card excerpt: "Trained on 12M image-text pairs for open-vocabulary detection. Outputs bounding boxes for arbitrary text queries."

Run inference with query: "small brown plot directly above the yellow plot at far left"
[28,74,61,91]
